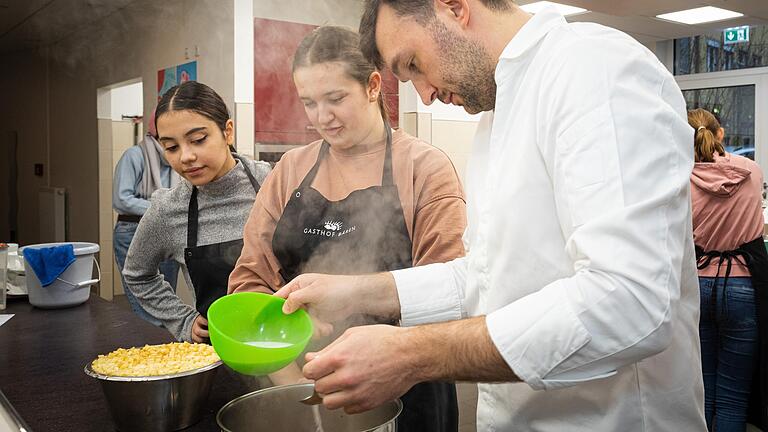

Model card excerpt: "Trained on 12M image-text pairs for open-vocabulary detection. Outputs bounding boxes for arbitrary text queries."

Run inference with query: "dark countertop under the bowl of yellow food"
[0,295,258,432]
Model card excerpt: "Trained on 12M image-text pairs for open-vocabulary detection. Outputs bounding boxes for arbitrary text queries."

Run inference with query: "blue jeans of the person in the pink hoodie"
[699,277,758,432]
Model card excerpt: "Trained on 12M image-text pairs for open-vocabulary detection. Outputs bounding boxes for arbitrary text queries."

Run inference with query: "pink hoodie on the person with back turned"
[691,153,763,277]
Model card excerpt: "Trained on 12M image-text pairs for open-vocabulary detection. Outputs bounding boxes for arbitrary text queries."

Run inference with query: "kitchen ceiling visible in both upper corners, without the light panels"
[0,0,768,52]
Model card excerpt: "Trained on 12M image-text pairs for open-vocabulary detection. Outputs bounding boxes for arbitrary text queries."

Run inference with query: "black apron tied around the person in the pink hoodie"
[696,236,768,430]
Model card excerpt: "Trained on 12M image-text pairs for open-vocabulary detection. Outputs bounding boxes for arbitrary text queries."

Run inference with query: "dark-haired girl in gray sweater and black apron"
[123,81,270,342]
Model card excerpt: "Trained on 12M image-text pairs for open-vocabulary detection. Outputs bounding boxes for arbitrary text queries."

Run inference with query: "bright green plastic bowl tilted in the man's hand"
[208,292,312,375]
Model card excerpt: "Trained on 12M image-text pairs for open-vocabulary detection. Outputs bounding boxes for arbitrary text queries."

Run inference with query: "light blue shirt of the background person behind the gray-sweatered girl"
[112,145,171,216]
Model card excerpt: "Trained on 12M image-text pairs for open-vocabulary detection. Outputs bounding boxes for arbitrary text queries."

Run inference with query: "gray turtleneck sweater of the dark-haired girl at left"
[123,160,270,341]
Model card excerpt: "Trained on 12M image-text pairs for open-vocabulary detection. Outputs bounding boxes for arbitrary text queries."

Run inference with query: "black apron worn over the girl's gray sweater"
[184,154,259,318]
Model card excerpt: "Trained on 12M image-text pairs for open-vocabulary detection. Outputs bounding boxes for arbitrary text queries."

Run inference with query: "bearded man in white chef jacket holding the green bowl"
[278,0,706,432]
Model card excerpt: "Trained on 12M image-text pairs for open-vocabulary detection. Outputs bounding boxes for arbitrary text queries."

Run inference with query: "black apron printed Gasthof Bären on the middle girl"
[272,126,458,432]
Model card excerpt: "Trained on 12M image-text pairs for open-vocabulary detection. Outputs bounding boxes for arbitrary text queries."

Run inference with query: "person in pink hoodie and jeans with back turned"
[688,109,763,432]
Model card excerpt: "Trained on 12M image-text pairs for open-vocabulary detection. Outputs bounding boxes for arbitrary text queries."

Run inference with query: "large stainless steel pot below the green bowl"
[216,384,403,432]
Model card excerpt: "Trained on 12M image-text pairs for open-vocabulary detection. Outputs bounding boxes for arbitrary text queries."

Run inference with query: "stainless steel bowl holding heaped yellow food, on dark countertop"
[85,361,221,432]
